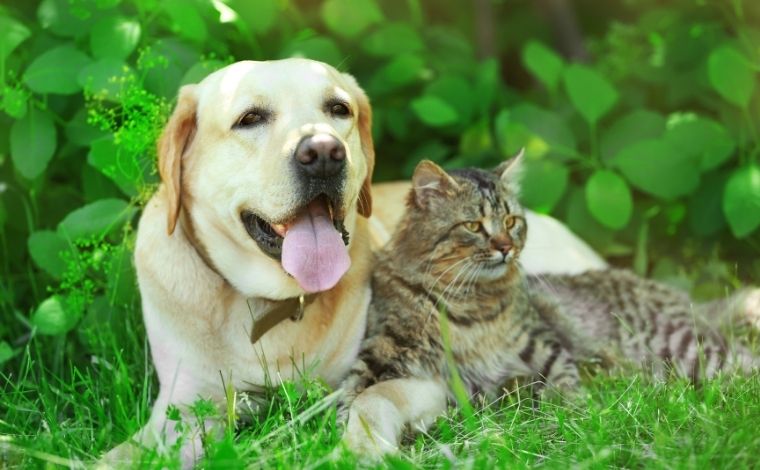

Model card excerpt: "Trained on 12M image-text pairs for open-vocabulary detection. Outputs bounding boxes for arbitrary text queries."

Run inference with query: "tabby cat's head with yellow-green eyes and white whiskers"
[404,152,527,282]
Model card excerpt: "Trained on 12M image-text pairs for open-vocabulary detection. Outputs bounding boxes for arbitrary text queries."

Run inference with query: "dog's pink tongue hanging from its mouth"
[282,202,351,292]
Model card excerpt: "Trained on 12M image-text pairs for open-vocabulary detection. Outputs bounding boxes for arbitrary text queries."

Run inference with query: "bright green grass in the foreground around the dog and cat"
[0,306,760,468]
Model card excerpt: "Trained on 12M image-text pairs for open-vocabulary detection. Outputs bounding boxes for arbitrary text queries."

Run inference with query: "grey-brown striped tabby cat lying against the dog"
[339,156,760,455]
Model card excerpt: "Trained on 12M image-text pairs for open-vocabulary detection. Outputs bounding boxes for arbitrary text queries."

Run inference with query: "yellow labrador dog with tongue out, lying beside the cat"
[106,59,603,465]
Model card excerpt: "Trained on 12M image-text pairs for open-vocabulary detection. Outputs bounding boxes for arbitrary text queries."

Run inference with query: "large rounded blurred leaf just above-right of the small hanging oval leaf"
[611,140,699,201]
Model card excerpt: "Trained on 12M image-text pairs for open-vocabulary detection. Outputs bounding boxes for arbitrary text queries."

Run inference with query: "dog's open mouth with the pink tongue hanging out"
[240,196,351,292]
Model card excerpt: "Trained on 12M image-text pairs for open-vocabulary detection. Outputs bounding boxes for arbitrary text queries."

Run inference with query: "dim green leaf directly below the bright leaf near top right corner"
[665,115,736,171]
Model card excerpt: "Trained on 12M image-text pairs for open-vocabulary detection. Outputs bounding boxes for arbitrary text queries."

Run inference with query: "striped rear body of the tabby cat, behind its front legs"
[529,269,760,382]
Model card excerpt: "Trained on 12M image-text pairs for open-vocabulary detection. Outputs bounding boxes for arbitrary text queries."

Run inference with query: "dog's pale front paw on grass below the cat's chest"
[344,378,447,458]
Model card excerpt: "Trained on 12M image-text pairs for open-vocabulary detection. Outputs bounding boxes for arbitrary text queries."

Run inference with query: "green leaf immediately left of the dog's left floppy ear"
[87,136,143,196]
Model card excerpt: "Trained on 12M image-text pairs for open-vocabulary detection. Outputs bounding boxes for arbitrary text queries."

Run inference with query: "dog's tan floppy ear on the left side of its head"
[158,85,198,235]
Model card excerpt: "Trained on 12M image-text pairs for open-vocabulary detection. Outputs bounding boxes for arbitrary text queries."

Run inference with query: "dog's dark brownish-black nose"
[295,133,346,178]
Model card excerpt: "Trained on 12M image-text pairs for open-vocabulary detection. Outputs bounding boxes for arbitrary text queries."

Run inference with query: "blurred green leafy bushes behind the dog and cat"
[0,0,760,350]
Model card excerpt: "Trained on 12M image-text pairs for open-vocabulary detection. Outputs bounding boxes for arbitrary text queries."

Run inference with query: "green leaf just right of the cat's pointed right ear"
[520,160,570,214]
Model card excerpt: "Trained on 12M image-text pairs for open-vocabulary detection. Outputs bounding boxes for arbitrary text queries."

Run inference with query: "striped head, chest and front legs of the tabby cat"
[344,155,578,422]
